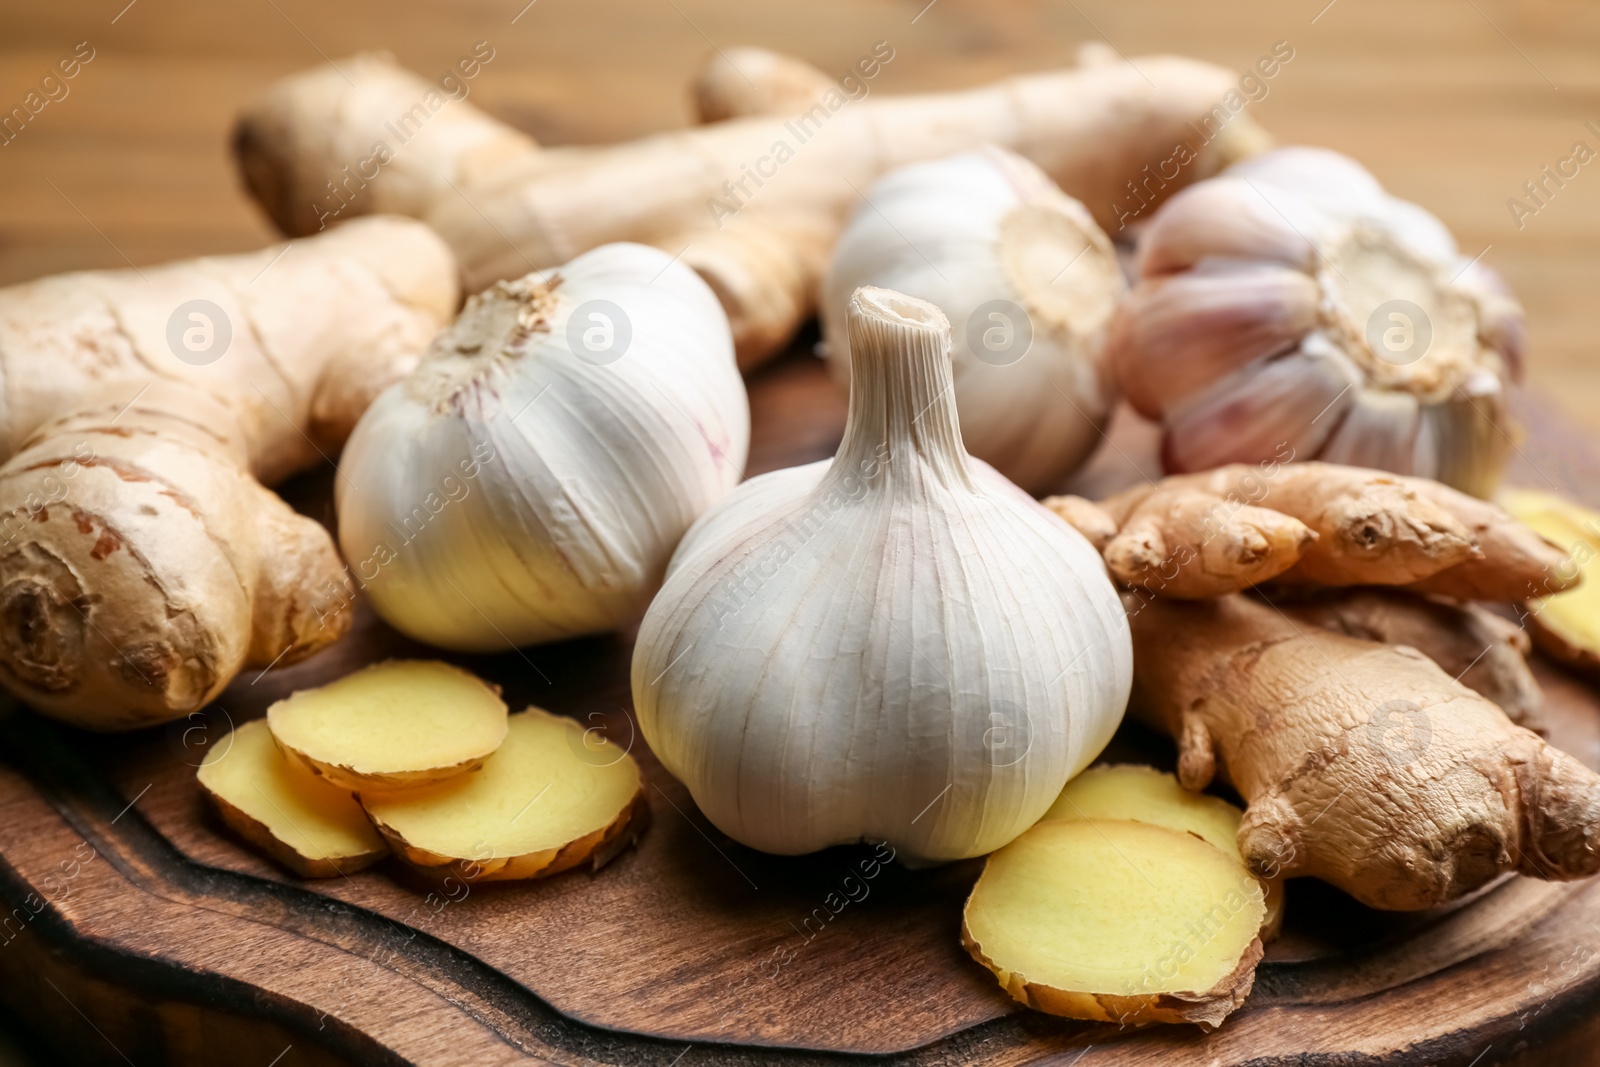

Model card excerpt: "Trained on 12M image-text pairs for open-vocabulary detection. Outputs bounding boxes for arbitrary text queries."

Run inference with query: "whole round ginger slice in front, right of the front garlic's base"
[962,819,1266,1030]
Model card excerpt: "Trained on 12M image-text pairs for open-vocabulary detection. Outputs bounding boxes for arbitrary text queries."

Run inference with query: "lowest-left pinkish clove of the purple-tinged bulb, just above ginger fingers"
[1162,333,1360,472]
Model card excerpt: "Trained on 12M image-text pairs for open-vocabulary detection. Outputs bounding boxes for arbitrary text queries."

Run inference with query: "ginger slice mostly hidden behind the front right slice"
[1040,763,1283,941]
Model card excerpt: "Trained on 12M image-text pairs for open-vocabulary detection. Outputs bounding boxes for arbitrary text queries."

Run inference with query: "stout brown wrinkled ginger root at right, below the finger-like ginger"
[1130,595,1600,910]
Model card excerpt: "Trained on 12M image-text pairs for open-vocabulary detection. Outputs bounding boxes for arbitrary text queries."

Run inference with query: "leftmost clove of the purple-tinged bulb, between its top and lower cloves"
[1107,261,1318,419]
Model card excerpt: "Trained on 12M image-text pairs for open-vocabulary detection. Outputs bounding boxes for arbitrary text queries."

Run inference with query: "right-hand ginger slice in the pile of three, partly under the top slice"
[360,707,645,881]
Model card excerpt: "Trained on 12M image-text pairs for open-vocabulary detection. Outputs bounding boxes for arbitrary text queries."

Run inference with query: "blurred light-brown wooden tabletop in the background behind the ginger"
[0,0,1600,429]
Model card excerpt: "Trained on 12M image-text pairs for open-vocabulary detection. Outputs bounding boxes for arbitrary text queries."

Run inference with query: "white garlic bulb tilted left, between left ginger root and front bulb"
[336,245,750,649]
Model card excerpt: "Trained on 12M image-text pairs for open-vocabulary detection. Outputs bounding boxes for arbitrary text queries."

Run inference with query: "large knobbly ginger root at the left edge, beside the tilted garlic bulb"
[0,218,456,729]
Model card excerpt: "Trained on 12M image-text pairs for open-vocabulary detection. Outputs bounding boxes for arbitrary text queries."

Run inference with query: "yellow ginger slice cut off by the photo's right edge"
[1499,490,1600,670]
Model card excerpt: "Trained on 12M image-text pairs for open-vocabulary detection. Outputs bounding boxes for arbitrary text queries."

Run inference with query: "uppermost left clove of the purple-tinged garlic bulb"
[1136,171,1322,278]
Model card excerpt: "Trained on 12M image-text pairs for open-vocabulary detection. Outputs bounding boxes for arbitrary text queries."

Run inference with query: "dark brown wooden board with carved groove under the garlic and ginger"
[0,344,1600,1067]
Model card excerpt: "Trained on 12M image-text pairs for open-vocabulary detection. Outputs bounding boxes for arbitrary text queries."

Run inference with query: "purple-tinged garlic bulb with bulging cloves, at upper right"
[1109,149,1522,496]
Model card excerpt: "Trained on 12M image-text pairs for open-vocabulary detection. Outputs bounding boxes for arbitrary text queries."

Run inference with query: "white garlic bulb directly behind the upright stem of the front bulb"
[821,147,1126,493]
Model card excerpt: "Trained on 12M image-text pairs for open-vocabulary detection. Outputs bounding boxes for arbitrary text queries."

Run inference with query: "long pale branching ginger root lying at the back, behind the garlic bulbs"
[234,50,1262,366]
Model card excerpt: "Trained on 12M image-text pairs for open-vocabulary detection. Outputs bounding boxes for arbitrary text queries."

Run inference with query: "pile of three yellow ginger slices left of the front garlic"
[197,661,645,881]
